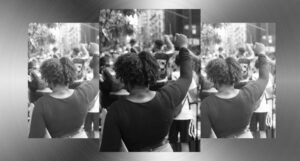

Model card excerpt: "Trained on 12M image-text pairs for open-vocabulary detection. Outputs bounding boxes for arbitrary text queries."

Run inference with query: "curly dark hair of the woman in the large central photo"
[115,51,159,86]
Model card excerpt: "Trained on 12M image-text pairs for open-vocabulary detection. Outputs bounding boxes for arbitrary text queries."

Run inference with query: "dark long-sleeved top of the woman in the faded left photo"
[29,80,99,137]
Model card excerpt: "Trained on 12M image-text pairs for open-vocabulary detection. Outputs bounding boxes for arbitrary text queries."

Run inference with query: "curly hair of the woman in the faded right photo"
[206,57,242,85]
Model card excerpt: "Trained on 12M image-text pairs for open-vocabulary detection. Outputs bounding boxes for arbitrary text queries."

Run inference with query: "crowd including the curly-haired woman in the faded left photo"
[28,43,100,138]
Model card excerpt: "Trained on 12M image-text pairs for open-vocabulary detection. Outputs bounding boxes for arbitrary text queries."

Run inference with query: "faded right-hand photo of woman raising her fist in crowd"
[200,22,276,139]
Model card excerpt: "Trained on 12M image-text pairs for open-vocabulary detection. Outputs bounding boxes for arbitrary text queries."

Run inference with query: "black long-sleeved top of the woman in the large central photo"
[100,48,192,151]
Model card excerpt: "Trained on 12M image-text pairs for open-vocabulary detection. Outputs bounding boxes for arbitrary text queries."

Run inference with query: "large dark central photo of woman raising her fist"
[99,9,201,152]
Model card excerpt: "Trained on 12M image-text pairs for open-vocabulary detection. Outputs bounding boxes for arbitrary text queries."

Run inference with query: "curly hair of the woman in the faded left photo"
[40,57,76,85]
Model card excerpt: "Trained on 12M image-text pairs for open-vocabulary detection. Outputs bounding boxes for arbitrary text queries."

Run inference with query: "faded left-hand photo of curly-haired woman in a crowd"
[27,23,100,138]
